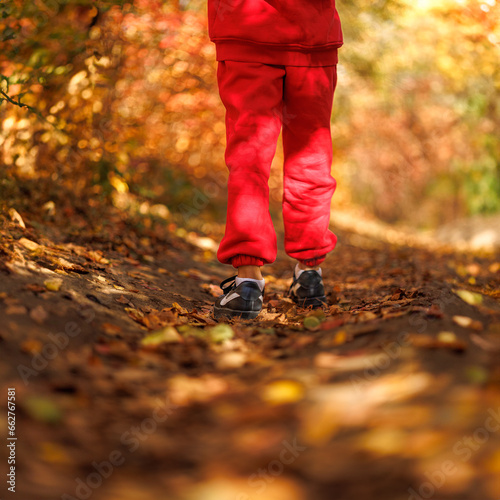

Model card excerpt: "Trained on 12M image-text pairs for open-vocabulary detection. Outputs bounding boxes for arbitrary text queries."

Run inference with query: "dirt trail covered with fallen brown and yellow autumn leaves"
[0,216,500,500]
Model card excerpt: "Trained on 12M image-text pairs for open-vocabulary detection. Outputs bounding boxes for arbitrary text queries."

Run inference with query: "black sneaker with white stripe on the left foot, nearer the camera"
[214,276,264,319]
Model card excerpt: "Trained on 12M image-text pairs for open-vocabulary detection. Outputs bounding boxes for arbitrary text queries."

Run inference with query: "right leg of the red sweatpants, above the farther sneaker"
[283,66,337,265]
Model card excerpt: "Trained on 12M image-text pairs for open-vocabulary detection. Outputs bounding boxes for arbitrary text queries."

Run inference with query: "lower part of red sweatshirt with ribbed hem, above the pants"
[208,0,342,66]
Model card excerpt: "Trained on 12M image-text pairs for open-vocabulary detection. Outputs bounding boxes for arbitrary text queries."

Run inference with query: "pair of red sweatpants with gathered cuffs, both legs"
[217,61,337,267]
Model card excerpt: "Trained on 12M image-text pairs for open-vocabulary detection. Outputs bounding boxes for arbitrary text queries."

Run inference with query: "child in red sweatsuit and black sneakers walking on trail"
[208,0,342,318]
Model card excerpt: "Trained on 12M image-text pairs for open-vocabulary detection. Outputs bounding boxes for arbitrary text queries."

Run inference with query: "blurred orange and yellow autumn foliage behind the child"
[0,0,500,238]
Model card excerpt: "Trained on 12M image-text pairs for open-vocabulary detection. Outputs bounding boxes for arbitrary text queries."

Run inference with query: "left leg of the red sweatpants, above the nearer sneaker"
[217,61,285,267]
